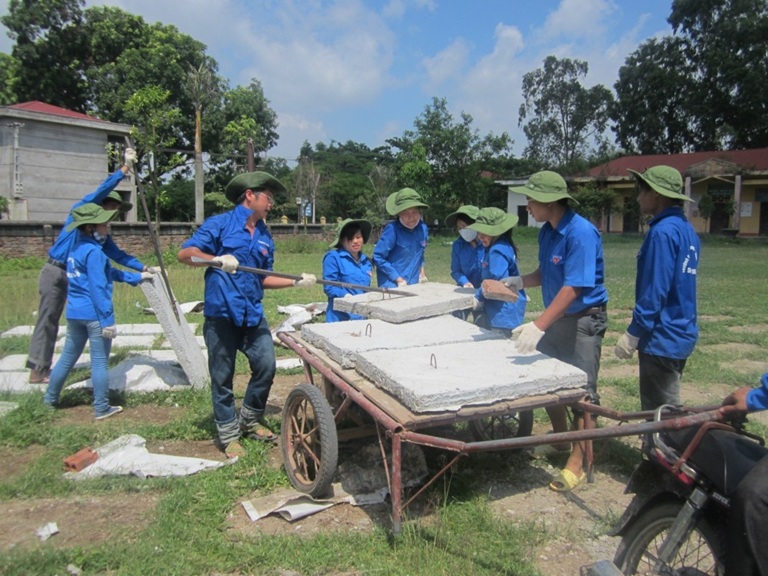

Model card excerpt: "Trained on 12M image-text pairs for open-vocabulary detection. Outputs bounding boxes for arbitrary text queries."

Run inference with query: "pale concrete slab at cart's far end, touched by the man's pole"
[333,282,475,324]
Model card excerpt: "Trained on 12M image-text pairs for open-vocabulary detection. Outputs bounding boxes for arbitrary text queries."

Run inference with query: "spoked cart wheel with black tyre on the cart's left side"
[280,384,339,497]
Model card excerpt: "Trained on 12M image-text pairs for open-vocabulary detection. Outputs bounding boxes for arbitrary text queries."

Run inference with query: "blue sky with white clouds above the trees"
[0,0,672,159]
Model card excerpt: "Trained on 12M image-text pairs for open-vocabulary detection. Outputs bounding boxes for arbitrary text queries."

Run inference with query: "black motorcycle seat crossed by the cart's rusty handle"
[663,427,768,496]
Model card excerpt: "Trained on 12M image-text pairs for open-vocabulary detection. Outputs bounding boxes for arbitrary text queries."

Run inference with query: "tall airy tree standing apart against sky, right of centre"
[518,56,613,170]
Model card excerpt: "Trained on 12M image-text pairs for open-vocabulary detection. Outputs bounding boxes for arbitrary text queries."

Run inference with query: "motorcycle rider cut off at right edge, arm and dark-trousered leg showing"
[720,373,768,576]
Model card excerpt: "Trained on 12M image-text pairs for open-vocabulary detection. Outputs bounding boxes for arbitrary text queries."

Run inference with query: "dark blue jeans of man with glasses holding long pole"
[203,317,276,445]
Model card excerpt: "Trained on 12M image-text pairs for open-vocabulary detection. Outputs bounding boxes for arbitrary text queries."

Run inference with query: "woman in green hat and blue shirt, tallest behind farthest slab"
[373,188,429,288]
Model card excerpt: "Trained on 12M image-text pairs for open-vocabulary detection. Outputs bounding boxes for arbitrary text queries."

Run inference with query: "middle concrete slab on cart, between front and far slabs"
[301,315,504,368]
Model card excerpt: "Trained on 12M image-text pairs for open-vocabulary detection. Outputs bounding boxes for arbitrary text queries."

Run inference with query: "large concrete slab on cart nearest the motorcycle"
[356,339,587,412]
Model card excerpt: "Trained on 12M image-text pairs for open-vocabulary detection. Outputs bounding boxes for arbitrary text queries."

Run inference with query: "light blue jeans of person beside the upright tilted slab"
[43,320,112,416]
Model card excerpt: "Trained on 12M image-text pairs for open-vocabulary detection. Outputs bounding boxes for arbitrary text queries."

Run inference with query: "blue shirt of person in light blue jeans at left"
[67,230,141,328]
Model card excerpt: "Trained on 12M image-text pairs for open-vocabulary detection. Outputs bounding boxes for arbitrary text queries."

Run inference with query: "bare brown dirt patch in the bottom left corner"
[0,494,156,550]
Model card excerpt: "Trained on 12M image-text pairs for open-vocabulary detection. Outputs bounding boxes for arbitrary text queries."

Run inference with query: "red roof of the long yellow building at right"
[586,148,768,178]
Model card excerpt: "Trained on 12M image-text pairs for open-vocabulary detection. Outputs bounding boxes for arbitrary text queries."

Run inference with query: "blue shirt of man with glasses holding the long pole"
[181,204,275,327]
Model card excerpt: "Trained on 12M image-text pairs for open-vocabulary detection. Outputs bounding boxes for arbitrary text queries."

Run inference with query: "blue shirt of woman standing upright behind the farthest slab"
[373,218,429,288]
